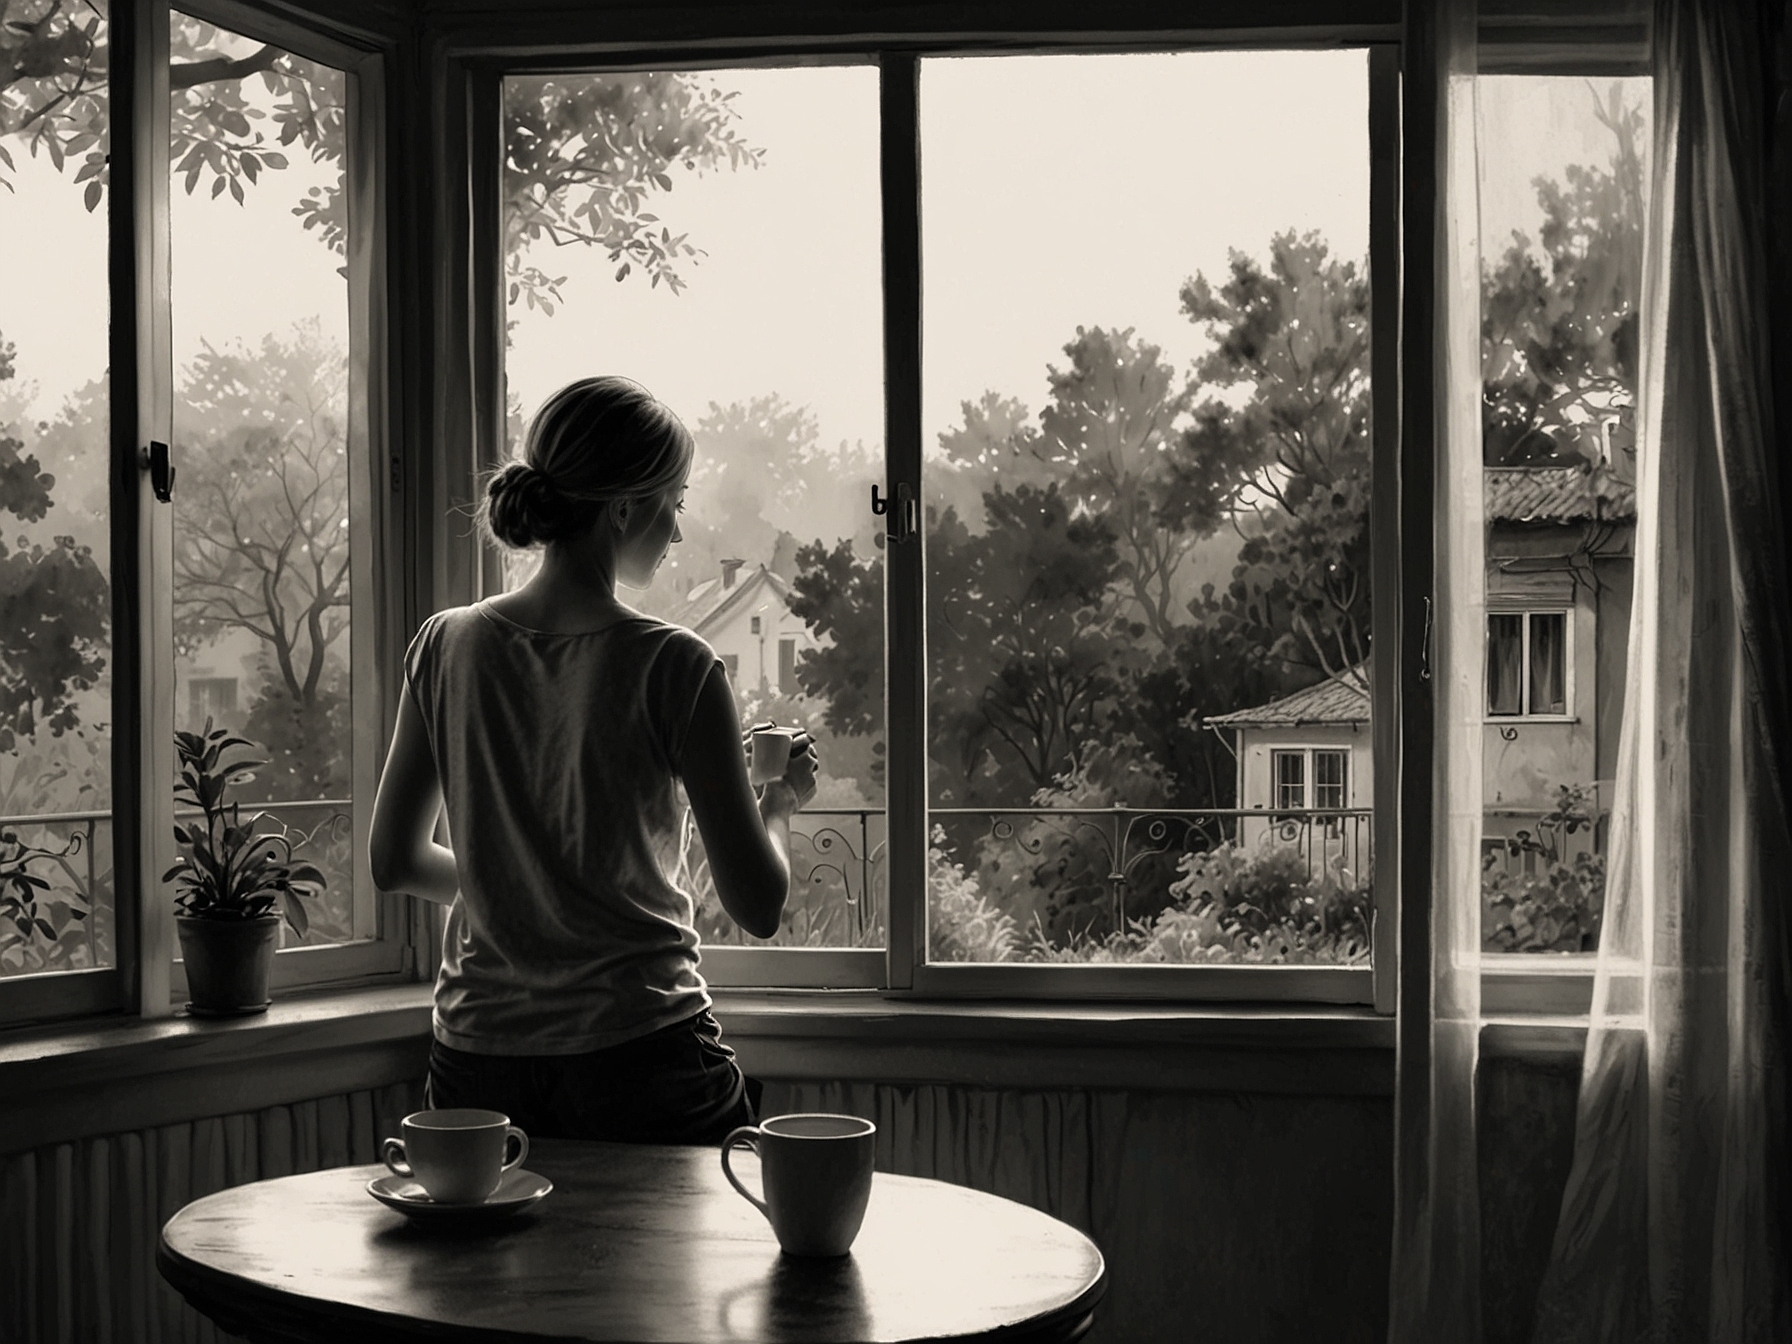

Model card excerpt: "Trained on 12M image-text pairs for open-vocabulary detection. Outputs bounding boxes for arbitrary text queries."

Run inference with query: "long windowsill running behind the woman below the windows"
[0,984,1584,1150]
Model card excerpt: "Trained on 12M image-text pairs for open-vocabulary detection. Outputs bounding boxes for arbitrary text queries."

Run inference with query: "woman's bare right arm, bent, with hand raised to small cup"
[683,667,815,937]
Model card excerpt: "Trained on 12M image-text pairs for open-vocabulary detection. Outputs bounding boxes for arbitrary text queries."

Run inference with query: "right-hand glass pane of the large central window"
[921,52,1371,962]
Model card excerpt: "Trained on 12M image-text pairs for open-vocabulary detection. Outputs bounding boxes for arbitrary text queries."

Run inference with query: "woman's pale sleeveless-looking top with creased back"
[405,602,720,1054]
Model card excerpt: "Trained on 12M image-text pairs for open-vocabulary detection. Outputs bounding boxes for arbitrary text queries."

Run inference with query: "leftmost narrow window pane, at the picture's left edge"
[0,4,115,977]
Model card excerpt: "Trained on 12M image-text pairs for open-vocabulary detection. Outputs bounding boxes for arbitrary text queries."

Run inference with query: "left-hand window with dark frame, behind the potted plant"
[0,2,410,1020]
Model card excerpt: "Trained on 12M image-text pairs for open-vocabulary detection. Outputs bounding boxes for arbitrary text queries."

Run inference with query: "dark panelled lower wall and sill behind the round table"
[0,991,1577,1344]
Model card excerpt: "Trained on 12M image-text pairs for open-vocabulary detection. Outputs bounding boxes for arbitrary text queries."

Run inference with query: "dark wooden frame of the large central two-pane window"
[462,32,1401,1011]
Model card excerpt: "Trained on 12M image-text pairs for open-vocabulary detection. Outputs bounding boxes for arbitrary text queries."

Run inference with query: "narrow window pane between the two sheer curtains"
[1478,75,1650,952]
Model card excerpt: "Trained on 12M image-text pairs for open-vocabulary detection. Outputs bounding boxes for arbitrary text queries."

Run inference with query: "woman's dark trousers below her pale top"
[423,1009,762,1143]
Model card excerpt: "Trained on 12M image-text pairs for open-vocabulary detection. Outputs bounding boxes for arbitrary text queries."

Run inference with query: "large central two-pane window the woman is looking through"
[476,43,1400,1004]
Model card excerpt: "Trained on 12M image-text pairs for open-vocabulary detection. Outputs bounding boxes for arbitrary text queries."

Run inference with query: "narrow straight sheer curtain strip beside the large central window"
[1389,0,1486,1344]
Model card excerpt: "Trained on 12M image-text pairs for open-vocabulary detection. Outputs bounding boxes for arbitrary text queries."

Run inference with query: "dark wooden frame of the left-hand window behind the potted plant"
[0,0,412,1025]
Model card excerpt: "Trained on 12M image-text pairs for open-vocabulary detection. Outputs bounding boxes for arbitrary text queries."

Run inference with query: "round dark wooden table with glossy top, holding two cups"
[156,1140,1107,1344]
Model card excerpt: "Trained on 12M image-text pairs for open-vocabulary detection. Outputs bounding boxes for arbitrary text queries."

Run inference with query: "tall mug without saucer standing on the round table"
[722,1113,878,1256]
